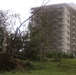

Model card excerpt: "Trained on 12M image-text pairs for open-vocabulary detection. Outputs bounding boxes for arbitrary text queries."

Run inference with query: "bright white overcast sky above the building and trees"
[0,0,76,18]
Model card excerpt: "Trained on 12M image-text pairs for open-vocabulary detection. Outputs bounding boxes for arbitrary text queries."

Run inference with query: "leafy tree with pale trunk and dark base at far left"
[0,10,22,70]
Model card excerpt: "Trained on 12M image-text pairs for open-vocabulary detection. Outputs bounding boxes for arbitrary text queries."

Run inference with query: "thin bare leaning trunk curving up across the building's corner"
[4,0,50,59]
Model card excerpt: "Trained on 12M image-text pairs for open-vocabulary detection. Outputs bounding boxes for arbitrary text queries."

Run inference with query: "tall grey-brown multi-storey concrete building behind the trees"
[32,3,76,52]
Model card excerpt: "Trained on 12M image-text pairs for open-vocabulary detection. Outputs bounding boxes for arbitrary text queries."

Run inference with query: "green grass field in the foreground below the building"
[0,59,76,75]
